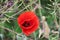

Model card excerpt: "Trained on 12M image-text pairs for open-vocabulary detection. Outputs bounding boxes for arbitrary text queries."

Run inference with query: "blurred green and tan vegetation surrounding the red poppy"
[0,0,60,40]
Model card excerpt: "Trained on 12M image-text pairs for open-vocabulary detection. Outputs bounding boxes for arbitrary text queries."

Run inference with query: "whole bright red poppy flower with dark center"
[17,11,39,36]
